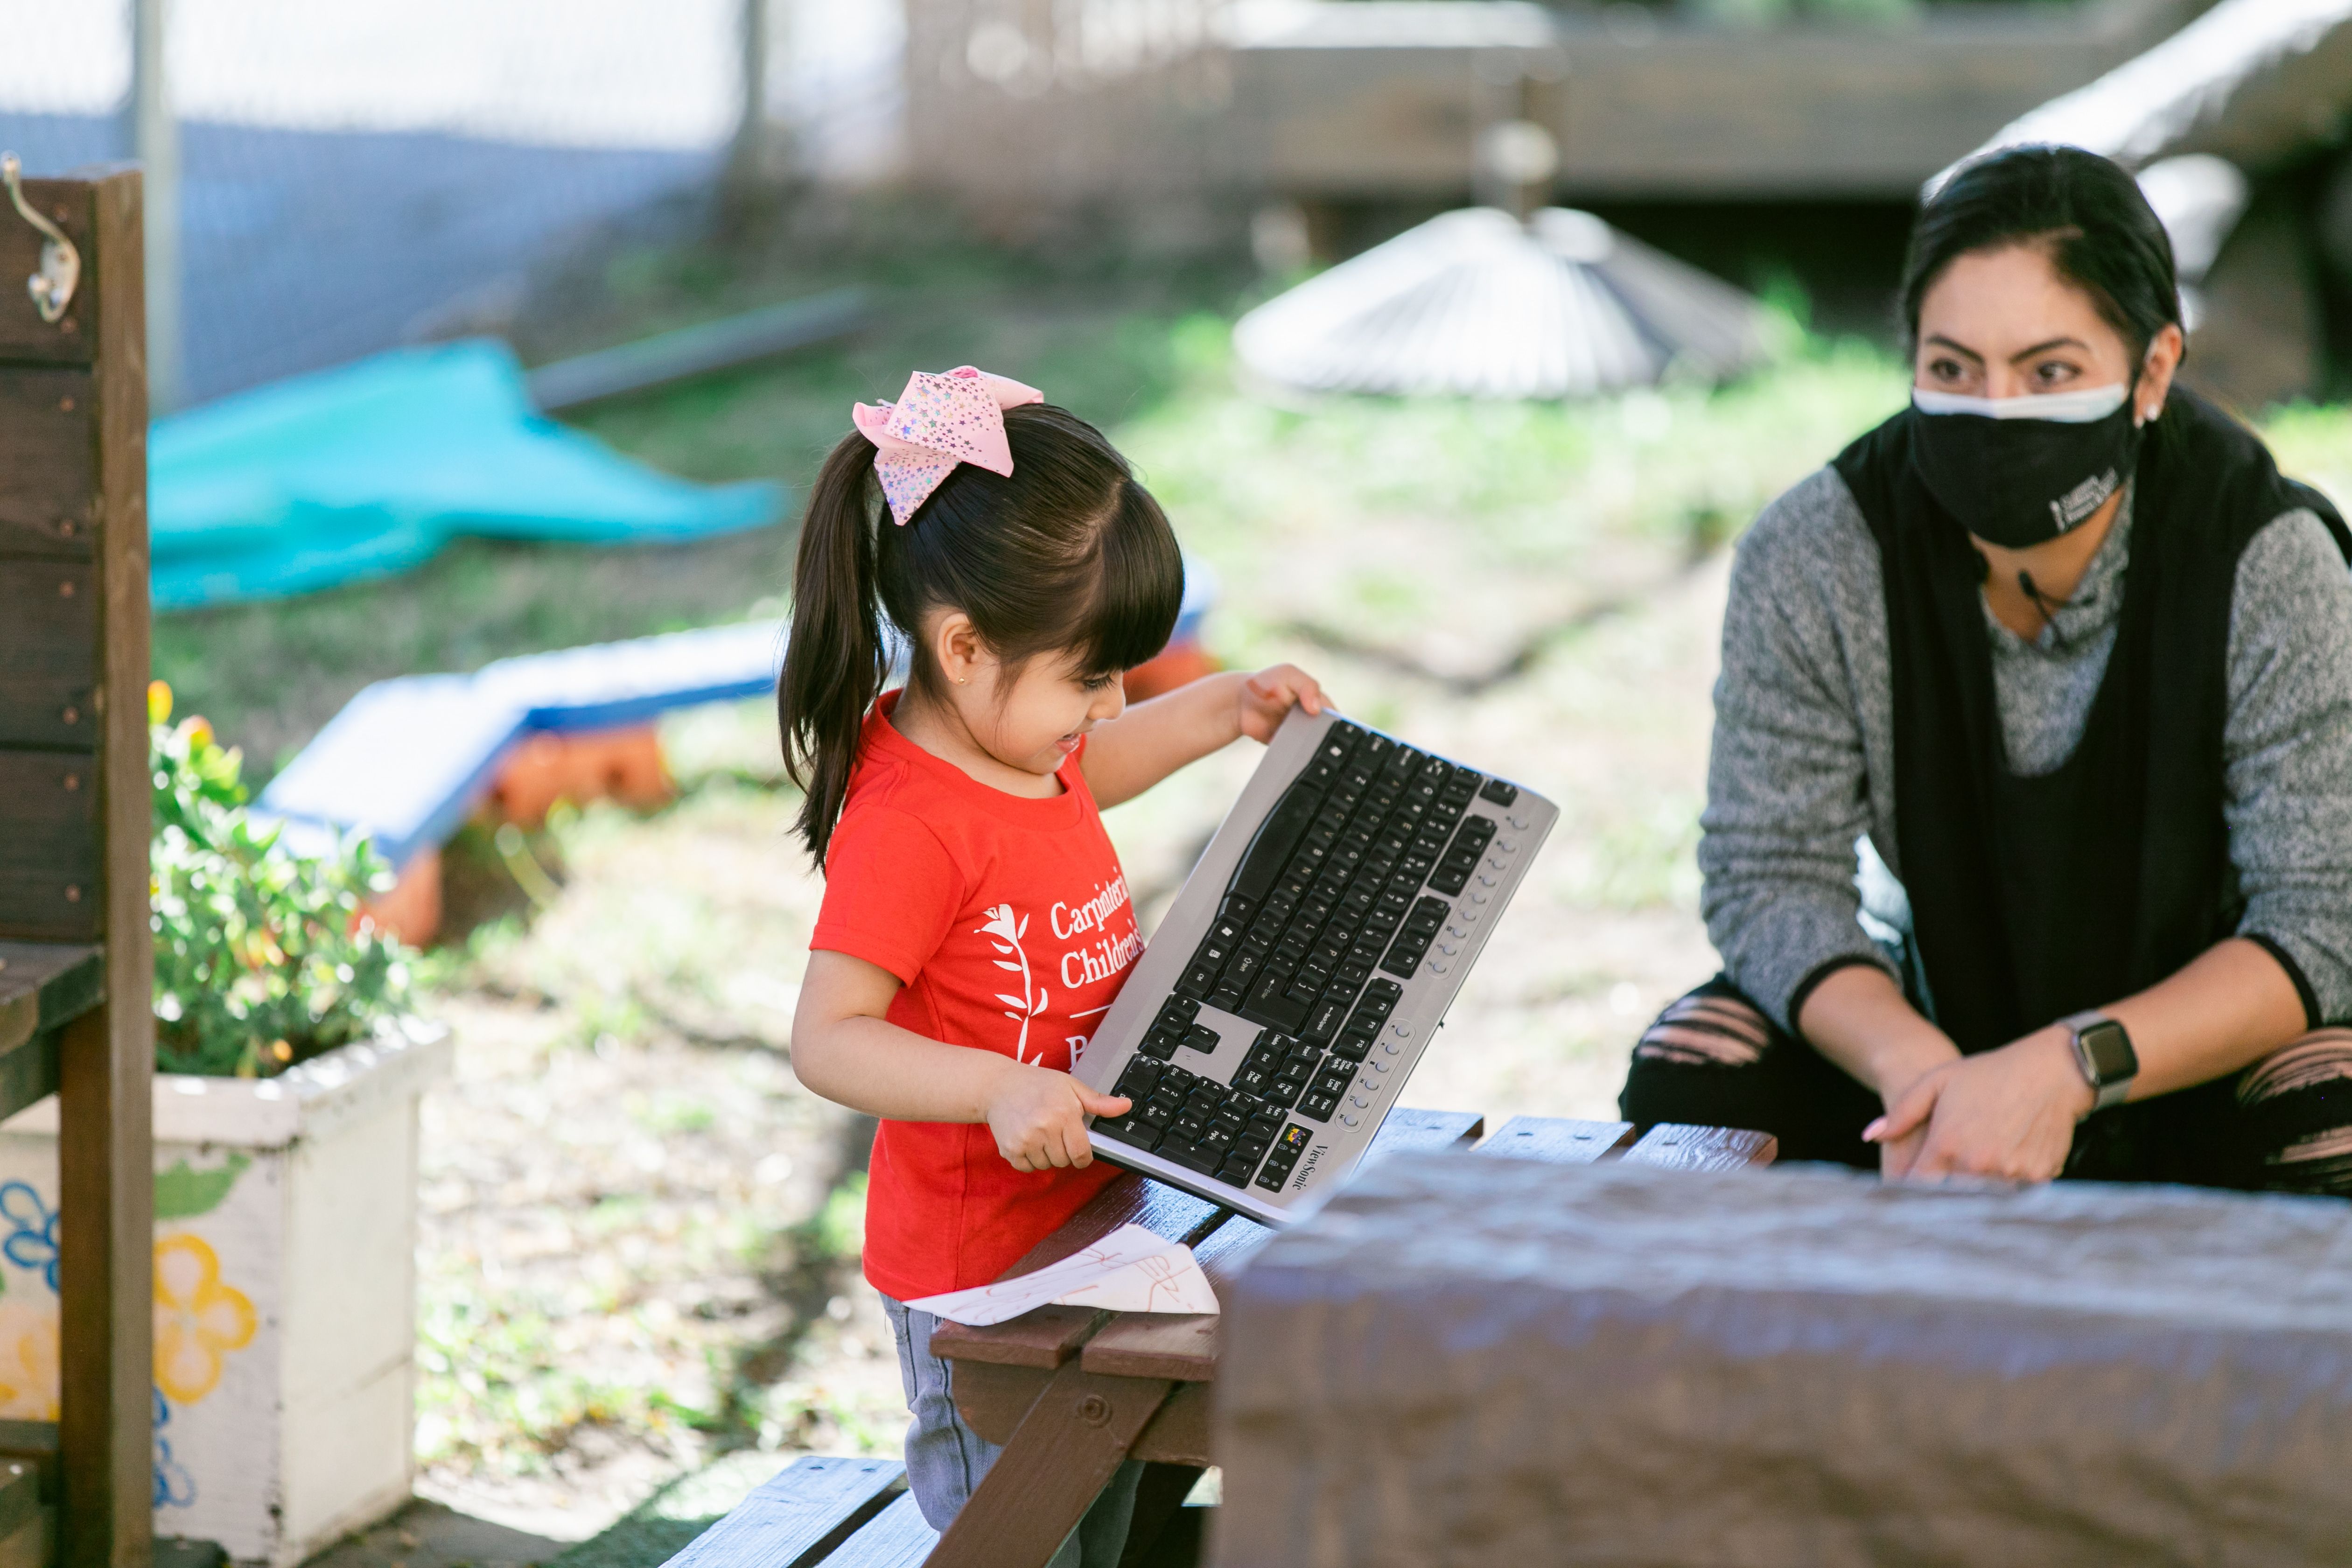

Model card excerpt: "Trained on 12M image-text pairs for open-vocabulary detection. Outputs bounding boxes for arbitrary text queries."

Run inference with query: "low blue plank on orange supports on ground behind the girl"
[259,560,1216,870]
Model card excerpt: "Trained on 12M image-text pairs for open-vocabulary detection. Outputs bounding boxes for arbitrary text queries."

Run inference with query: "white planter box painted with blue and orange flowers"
[0,1025,452,1568]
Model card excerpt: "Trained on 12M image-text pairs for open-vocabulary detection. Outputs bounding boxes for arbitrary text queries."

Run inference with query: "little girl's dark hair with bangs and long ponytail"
[776,404,1183,868]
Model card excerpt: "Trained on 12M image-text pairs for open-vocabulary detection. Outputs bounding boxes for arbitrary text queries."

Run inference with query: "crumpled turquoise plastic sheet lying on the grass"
[148,338,783,609]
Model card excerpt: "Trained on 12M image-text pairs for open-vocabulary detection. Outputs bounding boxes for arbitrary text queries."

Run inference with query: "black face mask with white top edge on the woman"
[1912,378,2140,550]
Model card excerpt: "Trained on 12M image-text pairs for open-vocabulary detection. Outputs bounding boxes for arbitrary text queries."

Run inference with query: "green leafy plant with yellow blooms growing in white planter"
[148,682,409,1077]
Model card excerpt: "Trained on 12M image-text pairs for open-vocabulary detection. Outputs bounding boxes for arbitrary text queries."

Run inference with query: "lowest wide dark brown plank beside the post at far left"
[0,750,104,943]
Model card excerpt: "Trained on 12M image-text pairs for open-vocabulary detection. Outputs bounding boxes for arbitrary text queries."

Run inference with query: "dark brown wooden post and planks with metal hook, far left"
[0,169,155,1568]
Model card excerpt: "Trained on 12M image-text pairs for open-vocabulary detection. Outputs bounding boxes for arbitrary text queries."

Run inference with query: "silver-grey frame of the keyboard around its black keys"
[1072,707,1560,1225]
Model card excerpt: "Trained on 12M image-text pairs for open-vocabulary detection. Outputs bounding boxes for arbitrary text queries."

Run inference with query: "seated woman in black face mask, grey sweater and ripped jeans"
[1621,148,2352,1194]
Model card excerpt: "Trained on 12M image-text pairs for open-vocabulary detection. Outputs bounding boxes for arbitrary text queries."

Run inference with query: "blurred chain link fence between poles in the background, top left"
[0,0,901,402]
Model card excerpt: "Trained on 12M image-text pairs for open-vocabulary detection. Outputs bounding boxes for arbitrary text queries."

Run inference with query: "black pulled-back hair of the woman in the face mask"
[1903,146,2180,362]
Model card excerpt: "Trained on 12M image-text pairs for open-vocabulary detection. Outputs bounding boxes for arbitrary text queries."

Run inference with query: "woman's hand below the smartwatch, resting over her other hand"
[1863,1025,2093,1183]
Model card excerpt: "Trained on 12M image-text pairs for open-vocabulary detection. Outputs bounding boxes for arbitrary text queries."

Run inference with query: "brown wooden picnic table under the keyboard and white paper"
[929,1107,1776,1568]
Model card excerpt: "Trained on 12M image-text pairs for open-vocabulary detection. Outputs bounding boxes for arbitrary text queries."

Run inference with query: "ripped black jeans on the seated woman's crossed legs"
[1618,976,2352,1197]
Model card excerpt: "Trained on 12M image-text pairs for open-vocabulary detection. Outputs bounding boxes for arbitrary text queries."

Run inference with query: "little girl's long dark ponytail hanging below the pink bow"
[776,435,889,868]
